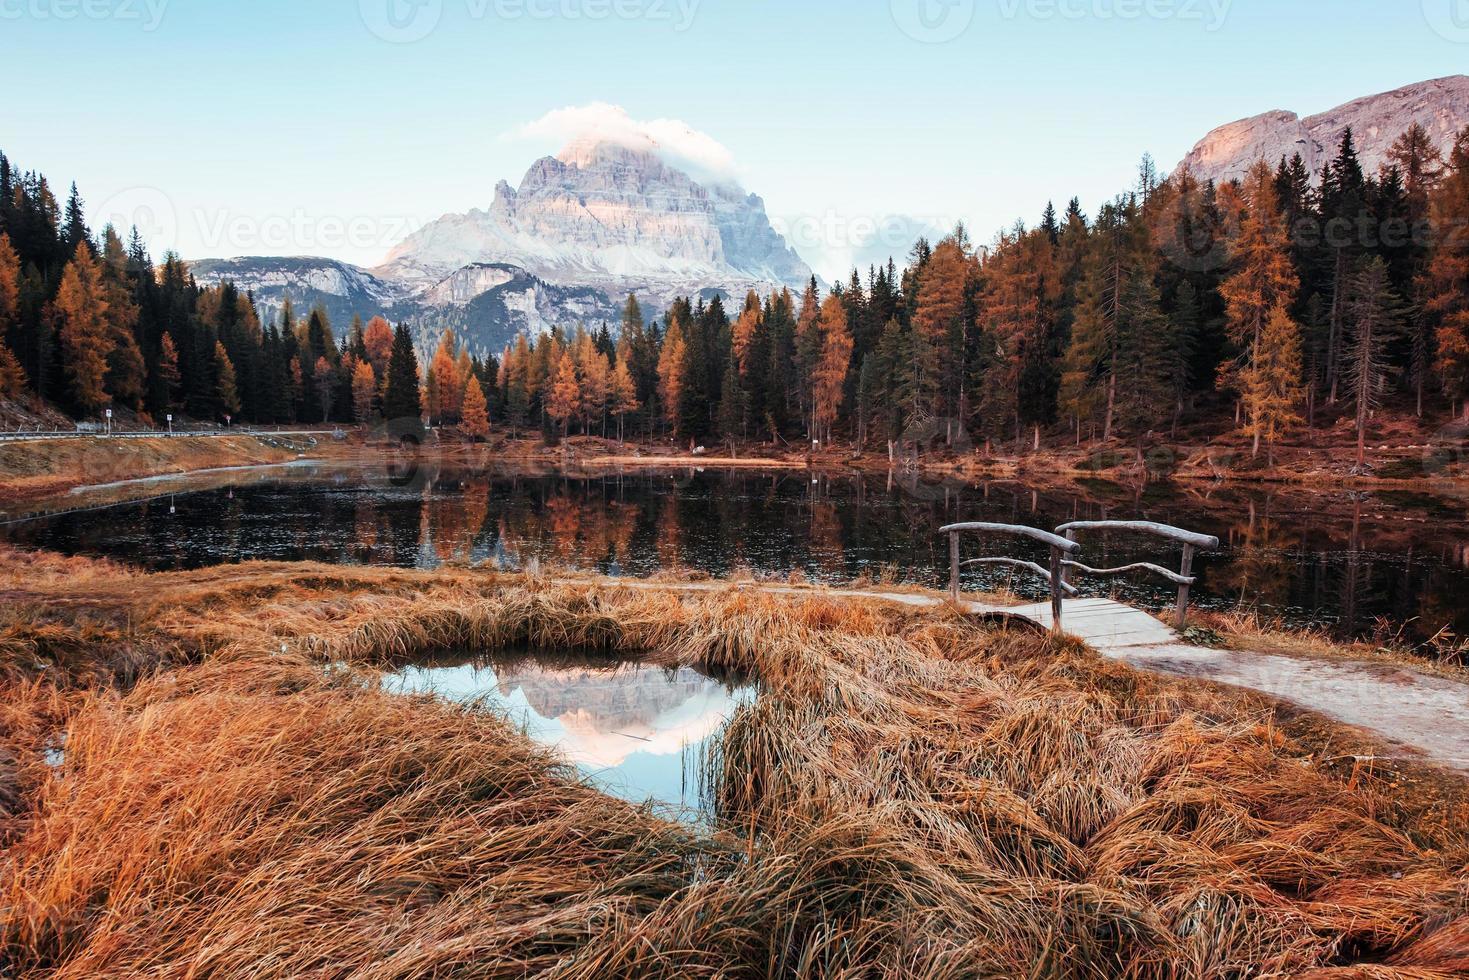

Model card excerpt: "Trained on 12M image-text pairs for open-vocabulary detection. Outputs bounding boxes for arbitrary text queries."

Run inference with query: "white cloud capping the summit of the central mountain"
[501,101,739,184]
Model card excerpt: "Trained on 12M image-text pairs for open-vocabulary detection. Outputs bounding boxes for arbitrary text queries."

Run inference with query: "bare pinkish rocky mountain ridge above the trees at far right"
[1183,75,1469,184]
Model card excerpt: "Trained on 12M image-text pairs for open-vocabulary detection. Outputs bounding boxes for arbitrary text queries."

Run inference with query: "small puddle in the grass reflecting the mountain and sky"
[386,654,757,814]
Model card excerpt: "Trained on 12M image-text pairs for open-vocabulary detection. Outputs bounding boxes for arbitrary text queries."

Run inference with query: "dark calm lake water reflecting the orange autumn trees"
[0,464,1469,639]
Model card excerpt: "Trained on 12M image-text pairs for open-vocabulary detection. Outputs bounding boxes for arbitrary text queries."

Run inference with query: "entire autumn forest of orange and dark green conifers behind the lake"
[0,125,1469,455]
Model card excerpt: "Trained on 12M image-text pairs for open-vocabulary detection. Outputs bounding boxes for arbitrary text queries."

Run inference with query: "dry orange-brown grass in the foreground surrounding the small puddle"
[0,549,1469,980]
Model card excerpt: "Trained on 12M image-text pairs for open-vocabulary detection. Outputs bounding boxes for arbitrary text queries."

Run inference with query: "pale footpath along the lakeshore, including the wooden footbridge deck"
[578,580,1469,774]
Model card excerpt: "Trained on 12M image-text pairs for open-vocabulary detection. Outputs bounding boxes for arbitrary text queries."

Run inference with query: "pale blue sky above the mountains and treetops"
[0,0,1469,278]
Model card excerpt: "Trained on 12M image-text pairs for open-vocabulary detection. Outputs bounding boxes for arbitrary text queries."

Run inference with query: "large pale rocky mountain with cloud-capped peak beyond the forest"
[192,141,811,353]
